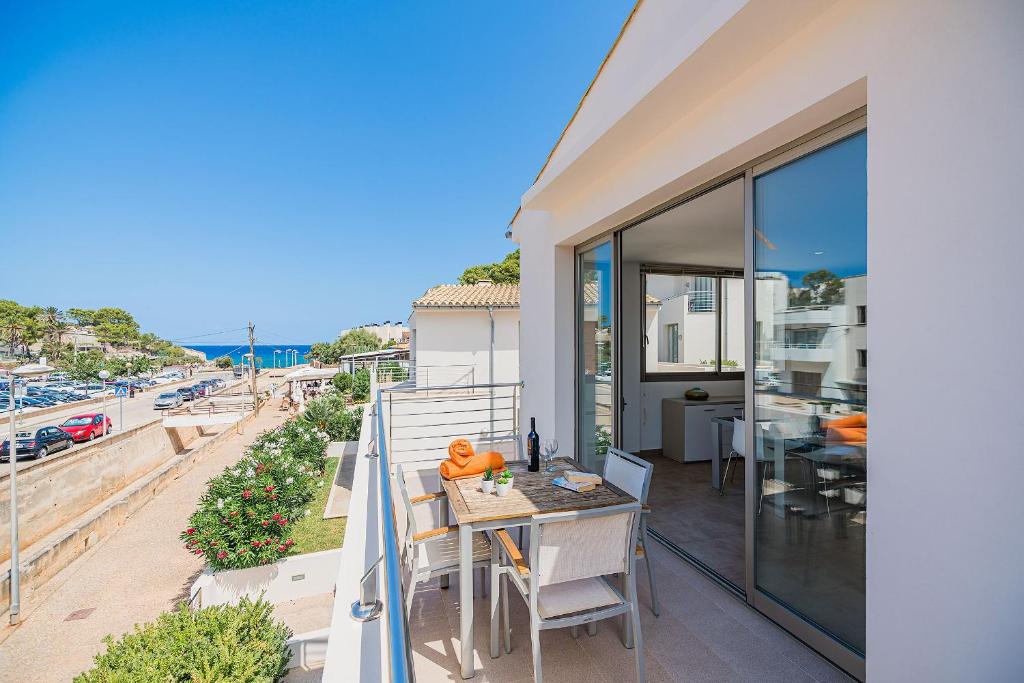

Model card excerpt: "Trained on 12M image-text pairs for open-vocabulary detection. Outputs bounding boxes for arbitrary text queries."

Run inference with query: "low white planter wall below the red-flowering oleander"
[188,548,341,607]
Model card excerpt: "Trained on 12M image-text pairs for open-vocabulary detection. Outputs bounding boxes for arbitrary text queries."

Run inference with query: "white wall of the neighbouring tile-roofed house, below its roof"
[411,307,519,386]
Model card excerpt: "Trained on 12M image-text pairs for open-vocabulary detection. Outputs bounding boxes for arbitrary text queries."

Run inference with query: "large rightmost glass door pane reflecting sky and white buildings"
[753,132,867,653]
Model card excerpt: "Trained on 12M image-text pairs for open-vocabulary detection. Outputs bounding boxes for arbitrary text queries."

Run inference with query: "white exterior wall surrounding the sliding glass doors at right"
[513,0,1024,681]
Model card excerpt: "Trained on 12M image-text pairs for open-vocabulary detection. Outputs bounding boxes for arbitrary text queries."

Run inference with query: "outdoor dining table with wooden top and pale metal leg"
[441,458,636,678]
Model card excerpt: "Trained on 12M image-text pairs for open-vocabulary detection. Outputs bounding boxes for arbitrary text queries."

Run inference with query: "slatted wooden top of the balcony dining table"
[441,458,636,524]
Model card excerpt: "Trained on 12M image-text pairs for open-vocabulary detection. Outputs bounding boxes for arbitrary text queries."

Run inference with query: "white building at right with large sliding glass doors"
[512,0,1024,680]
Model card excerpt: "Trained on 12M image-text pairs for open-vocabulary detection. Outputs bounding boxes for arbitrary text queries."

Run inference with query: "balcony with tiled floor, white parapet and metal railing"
[323,374,850,683]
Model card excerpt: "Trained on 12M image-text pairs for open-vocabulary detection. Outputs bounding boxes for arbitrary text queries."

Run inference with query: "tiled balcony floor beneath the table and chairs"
[411,543,852,683]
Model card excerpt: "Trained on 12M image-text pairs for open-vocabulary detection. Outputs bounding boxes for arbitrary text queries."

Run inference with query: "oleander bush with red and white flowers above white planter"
[181,420,329,570]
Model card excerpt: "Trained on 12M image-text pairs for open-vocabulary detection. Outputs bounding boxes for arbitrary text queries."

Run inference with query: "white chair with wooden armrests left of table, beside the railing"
[394,465,490,611]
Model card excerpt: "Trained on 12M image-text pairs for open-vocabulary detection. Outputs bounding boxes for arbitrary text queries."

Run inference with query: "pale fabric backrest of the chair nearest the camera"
[529,503,640,586]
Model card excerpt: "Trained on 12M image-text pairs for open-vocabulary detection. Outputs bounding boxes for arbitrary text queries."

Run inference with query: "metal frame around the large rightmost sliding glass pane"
[743,110,867,681]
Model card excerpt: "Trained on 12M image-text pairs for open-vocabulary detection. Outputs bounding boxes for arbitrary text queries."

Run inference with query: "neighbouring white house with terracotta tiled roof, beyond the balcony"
[409,282,519,386]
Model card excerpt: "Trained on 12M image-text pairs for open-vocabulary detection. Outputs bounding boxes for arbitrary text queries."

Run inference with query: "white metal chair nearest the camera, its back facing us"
[490,503,644,683]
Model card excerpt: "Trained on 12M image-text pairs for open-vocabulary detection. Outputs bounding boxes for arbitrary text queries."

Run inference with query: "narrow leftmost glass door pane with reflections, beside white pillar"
[577,242,614,472]
